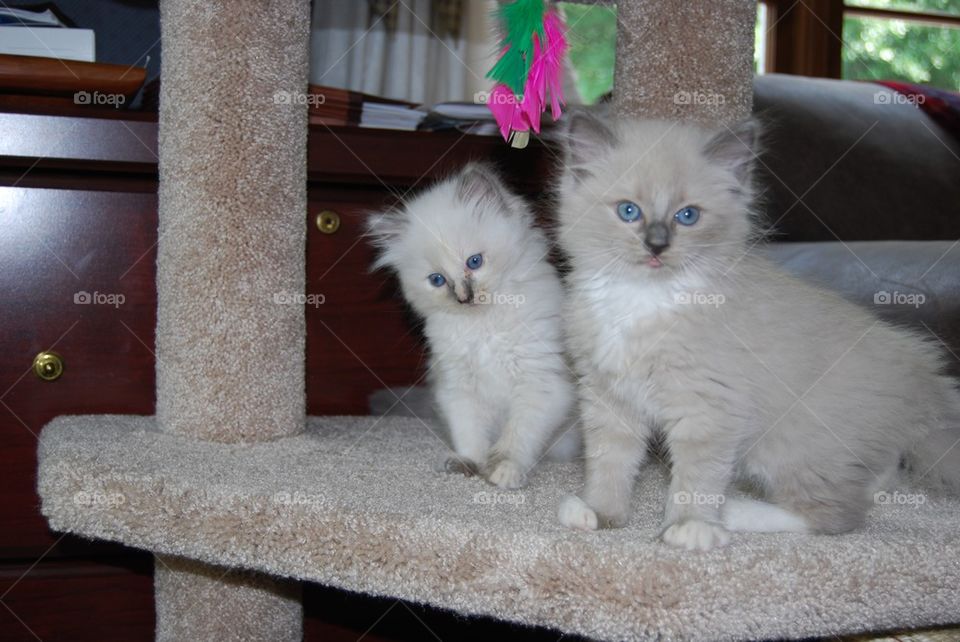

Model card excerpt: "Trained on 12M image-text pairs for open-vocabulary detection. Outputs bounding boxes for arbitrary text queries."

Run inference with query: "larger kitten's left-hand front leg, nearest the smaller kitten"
[559,398,650,530]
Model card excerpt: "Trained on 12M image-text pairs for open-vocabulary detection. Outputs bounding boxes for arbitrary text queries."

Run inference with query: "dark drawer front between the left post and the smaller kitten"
[306,190,425,415]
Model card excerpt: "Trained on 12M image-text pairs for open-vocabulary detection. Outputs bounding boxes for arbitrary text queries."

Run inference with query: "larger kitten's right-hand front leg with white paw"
[660,419,736,551]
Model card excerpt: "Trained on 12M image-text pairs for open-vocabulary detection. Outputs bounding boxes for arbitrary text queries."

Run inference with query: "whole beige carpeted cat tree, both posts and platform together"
[38,0,960,640]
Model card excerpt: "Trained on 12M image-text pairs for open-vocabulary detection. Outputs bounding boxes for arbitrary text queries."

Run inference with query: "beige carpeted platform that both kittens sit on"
[38,416,960,640]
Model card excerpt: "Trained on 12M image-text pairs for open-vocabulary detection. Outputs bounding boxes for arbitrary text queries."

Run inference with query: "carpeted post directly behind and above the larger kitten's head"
[613,0,757,125]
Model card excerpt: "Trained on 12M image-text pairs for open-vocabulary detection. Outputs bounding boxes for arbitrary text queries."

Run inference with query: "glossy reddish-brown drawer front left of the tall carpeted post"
[0,187,157,557]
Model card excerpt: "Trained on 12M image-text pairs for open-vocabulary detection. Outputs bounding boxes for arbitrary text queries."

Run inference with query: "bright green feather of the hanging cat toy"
[487,0,545,94]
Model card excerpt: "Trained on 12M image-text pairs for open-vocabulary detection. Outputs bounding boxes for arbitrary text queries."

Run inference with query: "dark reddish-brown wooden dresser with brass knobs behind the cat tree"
[0,107,552,640]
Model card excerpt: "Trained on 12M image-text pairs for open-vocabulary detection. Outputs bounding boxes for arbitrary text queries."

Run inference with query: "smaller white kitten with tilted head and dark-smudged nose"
[369,164,579,488]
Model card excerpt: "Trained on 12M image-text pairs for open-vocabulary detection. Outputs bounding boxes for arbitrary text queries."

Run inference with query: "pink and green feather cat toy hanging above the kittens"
[487,0,567,148]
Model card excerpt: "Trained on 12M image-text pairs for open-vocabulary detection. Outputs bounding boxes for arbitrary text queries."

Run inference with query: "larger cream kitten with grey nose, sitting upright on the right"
[559,115,960,550]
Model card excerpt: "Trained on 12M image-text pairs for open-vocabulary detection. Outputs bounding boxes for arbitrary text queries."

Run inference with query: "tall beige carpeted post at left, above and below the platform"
[156,0,310,640]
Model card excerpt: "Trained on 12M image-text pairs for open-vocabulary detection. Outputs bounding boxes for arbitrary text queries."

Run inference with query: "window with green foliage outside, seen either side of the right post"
[557,0,960,104]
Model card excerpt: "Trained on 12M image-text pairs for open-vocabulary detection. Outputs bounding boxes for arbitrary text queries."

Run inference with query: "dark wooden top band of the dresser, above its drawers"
[0,113,558,190]
